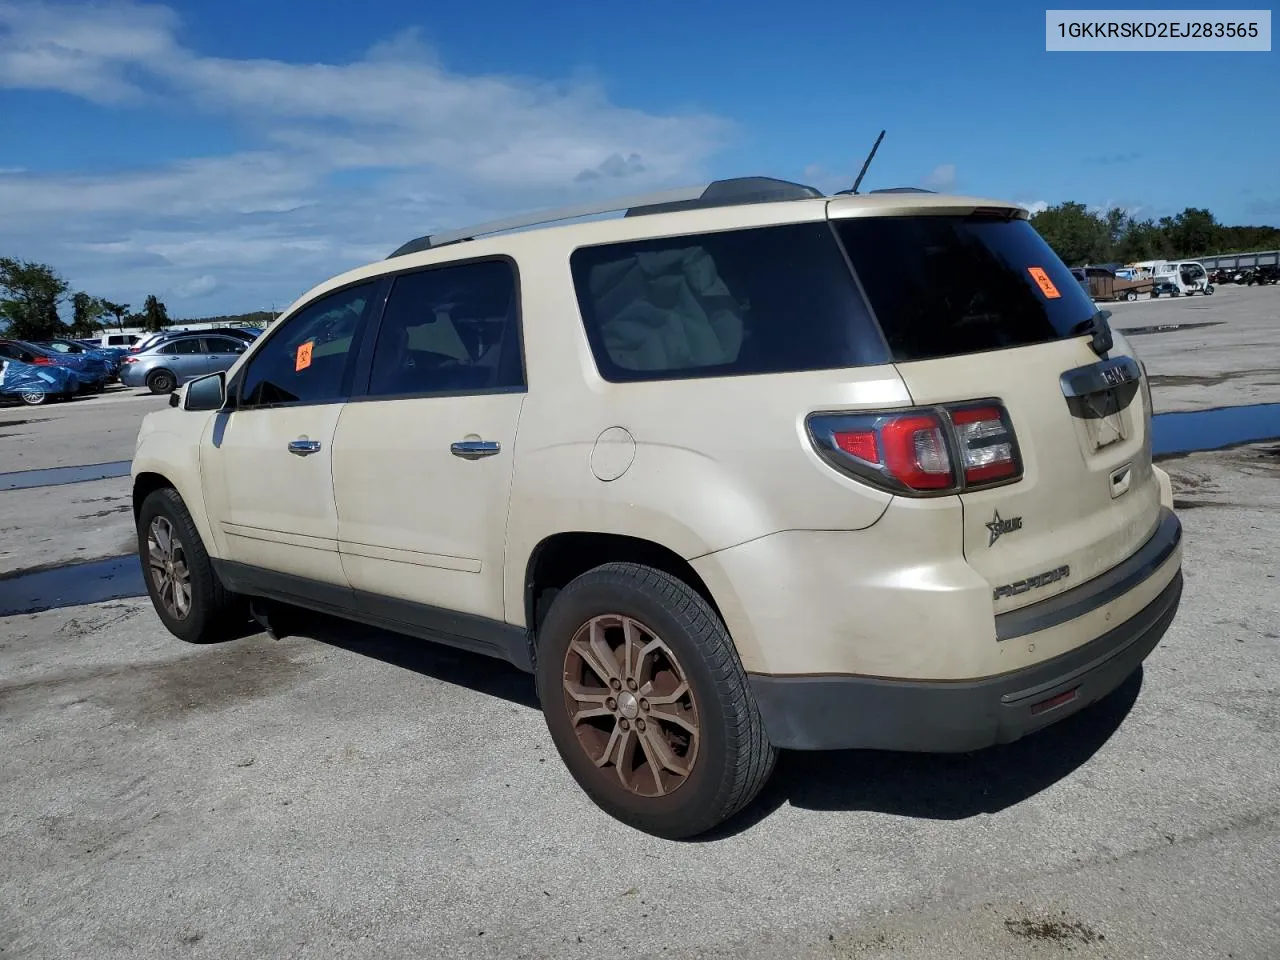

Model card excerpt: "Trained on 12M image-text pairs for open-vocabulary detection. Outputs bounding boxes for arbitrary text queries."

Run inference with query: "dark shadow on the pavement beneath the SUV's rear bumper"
[695,667,1142,842]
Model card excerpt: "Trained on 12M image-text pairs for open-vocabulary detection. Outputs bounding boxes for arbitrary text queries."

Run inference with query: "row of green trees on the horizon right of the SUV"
[1032,201,1280,266]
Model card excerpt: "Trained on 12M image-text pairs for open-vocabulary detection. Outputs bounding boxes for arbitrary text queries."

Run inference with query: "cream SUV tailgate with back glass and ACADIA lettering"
[835,214,1160,613]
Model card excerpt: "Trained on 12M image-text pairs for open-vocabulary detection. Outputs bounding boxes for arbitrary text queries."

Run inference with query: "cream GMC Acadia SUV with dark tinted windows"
[133,178,1183,837]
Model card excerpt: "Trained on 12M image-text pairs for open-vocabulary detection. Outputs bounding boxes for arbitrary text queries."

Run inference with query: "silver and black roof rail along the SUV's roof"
[388,177,824,260]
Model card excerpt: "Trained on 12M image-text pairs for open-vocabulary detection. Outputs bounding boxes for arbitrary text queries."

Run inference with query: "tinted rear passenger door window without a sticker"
[369,260,525,397]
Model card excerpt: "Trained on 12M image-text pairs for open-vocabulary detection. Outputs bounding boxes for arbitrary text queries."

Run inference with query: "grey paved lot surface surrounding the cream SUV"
[0,288,1280,960]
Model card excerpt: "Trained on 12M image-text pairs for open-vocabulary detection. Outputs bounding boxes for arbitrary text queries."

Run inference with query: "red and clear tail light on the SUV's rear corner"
[808,401,1023,497]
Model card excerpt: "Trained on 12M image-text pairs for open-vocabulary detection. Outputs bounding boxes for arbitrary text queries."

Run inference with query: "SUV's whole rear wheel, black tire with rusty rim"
[536,563,777,840]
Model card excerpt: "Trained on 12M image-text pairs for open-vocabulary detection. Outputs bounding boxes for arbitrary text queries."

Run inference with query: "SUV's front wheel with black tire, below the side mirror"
[138,486,247,644]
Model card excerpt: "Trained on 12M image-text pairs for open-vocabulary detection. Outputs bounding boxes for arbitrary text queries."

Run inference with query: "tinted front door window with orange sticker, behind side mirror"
[239,283,376,408]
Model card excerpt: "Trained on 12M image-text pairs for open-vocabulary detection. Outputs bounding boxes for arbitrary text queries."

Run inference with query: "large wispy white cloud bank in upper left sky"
[0,0,733,316]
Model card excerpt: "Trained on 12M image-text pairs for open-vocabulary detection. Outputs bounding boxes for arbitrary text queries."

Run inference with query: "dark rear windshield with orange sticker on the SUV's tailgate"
[836,215,1096,361]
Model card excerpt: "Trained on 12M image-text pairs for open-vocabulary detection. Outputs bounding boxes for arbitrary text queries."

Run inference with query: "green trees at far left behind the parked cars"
[0,257,170,340]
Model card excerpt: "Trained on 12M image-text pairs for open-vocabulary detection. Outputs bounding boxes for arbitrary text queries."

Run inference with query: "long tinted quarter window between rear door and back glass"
[570,221,887,383]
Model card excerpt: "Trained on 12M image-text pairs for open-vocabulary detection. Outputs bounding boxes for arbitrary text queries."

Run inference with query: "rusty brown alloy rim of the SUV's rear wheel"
[563,614,700,797]
